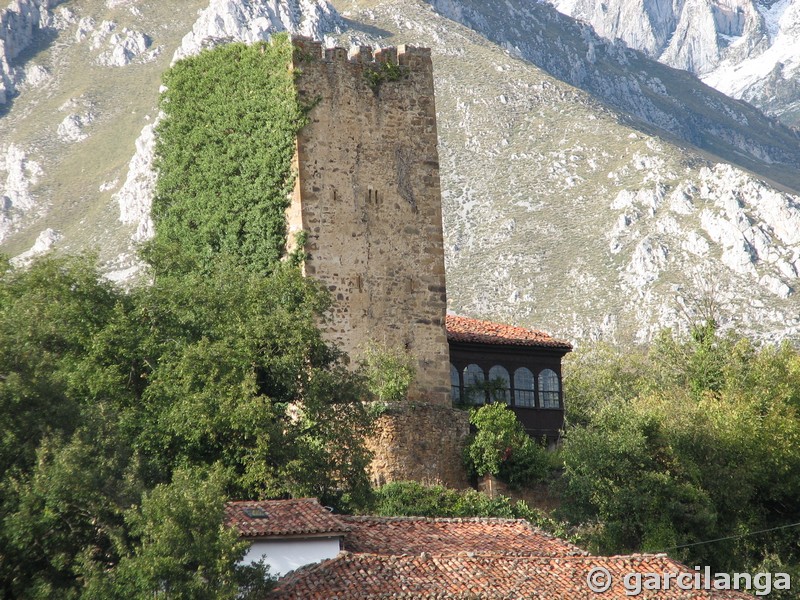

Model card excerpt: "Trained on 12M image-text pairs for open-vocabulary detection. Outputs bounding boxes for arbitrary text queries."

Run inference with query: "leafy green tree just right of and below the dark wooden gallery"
[563,403,716,553]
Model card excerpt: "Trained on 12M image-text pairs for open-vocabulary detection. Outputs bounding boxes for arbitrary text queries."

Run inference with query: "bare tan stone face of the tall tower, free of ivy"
[287,39,450,406]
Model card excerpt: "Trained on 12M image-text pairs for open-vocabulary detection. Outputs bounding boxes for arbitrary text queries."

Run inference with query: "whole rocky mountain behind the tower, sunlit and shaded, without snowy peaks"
[0,0,800,341]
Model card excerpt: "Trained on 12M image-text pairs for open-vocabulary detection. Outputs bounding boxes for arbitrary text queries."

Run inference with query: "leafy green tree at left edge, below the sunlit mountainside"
[0,258,118,480]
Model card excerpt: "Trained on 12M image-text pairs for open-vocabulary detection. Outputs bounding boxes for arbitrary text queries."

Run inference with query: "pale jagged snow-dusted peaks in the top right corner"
[551,0,800,125]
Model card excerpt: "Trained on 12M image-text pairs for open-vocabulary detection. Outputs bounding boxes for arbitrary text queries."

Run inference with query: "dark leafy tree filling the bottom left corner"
[0,407,136,599]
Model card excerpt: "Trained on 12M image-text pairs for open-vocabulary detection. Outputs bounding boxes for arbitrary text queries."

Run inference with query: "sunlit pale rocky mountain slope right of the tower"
[334,0,800,339]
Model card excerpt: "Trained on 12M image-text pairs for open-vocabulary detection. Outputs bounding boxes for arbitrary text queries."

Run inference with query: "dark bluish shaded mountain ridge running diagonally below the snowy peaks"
[429,0,800,191]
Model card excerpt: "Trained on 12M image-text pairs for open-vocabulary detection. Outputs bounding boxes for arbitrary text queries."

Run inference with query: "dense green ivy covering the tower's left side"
[146,35,305,273]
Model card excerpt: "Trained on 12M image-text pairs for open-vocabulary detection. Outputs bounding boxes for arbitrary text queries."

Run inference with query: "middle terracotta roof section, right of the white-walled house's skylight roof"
[339,516,586,556]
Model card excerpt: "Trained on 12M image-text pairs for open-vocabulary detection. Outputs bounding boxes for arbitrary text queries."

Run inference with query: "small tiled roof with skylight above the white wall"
[225,498,348,537]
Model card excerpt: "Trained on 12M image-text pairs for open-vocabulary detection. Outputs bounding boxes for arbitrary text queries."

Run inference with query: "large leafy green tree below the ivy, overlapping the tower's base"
[128,263,371,502]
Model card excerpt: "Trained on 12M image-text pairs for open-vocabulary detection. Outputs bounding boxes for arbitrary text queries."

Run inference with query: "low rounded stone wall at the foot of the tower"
[367,403,469,489]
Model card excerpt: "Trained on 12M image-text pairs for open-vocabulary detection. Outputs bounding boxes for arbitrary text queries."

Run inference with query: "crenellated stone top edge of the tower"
[292,35,431,71]
